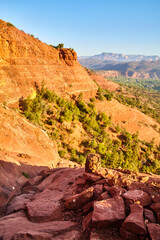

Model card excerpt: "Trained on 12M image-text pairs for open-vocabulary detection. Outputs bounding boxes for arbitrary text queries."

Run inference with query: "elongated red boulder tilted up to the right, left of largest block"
[66,187,94,209]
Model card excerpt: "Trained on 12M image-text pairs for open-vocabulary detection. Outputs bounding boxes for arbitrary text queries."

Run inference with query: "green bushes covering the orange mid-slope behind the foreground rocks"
[20,85,160,174]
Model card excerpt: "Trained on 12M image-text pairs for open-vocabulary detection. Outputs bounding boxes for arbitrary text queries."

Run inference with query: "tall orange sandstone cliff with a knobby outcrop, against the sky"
[0,20,97,102]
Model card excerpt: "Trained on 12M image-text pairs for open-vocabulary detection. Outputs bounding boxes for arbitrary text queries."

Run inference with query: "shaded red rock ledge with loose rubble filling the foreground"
[0,155,160,240]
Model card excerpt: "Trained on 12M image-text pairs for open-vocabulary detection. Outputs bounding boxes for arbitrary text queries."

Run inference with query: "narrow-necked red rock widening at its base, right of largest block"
[122,204,147,235]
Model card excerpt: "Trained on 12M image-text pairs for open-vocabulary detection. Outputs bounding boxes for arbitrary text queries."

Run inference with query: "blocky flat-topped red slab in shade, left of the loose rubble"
[26,190,63,222]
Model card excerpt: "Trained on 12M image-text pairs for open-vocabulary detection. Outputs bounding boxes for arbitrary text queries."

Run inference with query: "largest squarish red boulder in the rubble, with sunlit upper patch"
[92,196,125,226]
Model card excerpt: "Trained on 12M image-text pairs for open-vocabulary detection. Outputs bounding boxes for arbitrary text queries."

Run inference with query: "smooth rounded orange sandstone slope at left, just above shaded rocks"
[0,107,58,167]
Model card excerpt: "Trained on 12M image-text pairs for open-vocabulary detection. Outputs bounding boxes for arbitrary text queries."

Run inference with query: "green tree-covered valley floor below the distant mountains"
[107,77,160,125]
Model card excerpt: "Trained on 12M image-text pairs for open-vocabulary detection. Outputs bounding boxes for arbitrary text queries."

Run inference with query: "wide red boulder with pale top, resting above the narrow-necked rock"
[123,190,151,207]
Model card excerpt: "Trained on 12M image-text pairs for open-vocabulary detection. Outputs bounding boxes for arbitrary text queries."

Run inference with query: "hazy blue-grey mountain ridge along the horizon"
[78,53,160,79]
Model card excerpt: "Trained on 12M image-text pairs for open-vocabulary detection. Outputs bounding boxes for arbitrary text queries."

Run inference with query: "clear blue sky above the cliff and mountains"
[0,0,160,56]
